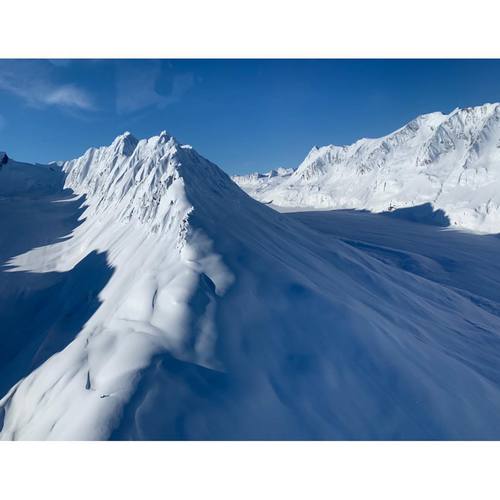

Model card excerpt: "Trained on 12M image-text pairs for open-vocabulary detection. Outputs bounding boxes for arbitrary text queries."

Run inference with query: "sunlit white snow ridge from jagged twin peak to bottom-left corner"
[2,134,239,439]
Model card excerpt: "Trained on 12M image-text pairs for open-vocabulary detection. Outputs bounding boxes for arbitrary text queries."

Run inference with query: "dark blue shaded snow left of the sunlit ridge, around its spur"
[0,189,113,400]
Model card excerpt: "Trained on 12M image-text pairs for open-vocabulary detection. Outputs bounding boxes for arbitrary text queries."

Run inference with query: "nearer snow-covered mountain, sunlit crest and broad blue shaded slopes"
[0,133,500,439]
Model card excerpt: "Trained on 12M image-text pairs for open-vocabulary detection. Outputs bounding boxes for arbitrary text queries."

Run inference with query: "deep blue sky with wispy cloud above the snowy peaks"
[0,60,500,174]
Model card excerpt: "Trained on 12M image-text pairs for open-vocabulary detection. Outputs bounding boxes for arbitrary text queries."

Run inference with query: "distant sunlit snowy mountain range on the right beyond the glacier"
[233,104,500,233]
